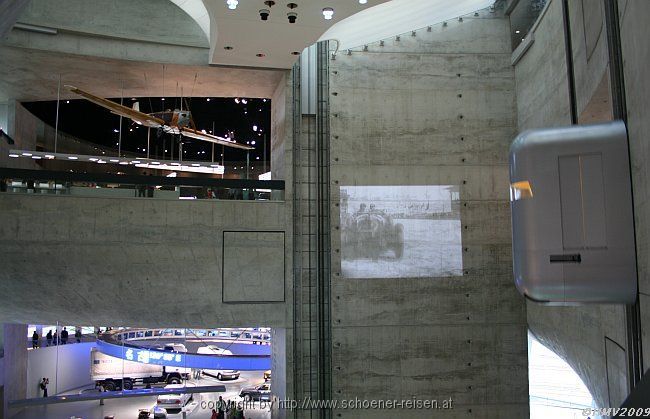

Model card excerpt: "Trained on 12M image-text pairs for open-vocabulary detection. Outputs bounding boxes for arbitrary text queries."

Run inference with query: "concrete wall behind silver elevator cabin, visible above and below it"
[515,0,627,406]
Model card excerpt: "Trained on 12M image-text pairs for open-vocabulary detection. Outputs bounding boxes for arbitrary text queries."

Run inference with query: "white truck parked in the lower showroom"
[90,349,189,391]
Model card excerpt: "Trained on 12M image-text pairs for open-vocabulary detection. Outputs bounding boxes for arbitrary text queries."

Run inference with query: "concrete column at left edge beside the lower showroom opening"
[3,323,26,418]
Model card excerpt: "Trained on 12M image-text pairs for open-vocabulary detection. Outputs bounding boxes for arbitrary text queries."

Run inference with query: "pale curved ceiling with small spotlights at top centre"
[171,0,495,68]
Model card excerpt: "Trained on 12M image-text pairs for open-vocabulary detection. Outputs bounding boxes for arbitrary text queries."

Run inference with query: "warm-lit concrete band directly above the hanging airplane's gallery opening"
[0,43,285,105]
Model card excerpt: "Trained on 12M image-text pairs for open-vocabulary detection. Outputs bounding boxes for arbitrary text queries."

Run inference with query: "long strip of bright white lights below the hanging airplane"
[9,150,225,175]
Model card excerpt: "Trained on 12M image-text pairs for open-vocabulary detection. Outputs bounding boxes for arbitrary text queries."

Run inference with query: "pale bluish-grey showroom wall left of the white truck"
[27,342,95,398]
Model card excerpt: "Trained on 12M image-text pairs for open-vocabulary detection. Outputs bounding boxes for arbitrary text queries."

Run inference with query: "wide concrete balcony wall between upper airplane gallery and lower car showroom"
[0,194,291,328]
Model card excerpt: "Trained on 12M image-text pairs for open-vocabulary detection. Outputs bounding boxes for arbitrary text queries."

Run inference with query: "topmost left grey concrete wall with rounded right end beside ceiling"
[5,0,210,64]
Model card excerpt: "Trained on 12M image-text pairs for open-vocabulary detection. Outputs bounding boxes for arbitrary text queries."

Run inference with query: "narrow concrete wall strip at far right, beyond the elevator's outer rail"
[619,0,650,378]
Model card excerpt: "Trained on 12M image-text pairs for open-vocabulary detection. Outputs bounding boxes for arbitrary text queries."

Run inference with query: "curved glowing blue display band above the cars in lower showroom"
[97,340,271,371]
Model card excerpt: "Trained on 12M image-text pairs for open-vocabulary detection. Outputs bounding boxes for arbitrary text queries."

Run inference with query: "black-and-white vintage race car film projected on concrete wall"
[340,185,463,278]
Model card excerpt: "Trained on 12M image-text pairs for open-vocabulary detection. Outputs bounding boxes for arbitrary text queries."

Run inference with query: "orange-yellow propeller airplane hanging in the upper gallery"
[66,85,255,150]
